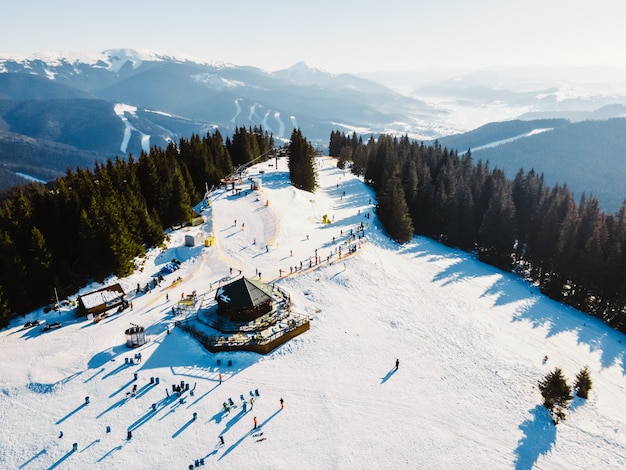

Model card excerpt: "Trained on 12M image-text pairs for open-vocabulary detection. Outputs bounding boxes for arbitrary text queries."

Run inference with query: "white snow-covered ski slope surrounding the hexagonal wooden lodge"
[0,158,626,469]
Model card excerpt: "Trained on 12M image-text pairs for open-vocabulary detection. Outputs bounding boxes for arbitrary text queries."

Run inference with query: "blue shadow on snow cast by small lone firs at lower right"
[515,405,556,470]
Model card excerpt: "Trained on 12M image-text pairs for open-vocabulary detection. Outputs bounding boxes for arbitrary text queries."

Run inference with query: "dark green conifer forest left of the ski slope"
[0,127,274,326]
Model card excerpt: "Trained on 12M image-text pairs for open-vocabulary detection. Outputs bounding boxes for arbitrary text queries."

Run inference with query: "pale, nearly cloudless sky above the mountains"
[0,0,626,73]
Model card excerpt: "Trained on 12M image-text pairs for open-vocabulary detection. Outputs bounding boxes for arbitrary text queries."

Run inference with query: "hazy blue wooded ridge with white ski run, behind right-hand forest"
[432,118,626,213]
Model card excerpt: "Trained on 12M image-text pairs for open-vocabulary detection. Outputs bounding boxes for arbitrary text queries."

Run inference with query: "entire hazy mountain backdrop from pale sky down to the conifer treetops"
[0,49,626,211]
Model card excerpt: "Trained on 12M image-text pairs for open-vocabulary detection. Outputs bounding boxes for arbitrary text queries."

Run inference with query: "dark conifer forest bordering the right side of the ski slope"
[329,131,626,333]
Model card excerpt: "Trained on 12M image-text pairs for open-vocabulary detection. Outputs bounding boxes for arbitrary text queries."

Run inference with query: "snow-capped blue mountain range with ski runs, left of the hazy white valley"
[0,50,440,186]
